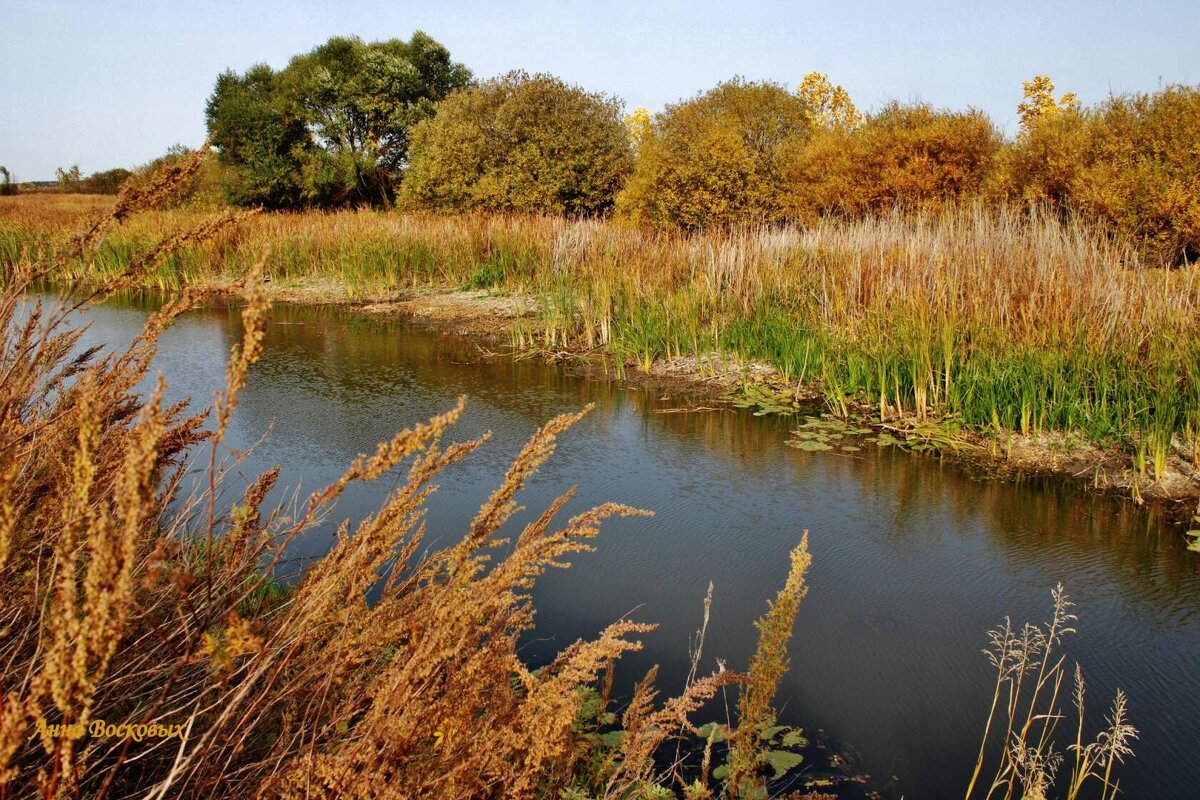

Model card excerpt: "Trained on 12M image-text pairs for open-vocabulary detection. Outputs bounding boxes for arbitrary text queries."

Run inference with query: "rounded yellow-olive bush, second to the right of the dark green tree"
[617,79,812,228]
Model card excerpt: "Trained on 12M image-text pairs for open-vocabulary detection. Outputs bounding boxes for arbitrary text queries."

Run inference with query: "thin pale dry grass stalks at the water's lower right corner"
[966,585,1138,800]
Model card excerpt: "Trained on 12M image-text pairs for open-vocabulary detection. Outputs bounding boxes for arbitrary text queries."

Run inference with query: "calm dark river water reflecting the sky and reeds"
[63,296,1200,798]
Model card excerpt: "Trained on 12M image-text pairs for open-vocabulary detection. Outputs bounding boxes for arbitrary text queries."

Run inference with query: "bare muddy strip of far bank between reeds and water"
[184,279,1200,523]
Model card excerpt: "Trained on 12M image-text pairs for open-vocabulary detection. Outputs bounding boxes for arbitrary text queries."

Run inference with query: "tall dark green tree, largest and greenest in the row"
[208,31,470,207]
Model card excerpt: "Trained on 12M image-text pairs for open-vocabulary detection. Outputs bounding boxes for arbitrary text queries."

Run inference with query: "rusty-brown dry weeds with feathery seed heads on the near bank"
[0,165,825,800]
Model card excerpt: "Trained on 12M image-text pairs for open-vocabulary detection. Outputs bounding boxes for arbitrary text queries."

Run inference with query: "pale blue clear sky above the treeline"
[0,0,1200,180]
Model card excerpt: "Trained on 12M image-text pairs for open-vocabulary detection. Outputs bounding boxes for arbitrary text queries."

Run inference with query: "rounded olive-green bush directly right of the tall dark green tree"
[401,72,632,215]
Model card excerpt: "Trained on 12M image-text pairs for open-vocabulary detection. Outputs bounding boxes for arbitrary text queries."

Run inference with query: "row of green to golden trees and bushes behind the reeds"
[46,32,1200,264]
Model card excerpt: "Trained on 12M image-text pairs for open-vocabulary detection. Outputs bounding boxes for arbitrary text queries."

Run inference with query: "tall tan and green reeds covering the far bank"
[0,190,1200,496]
